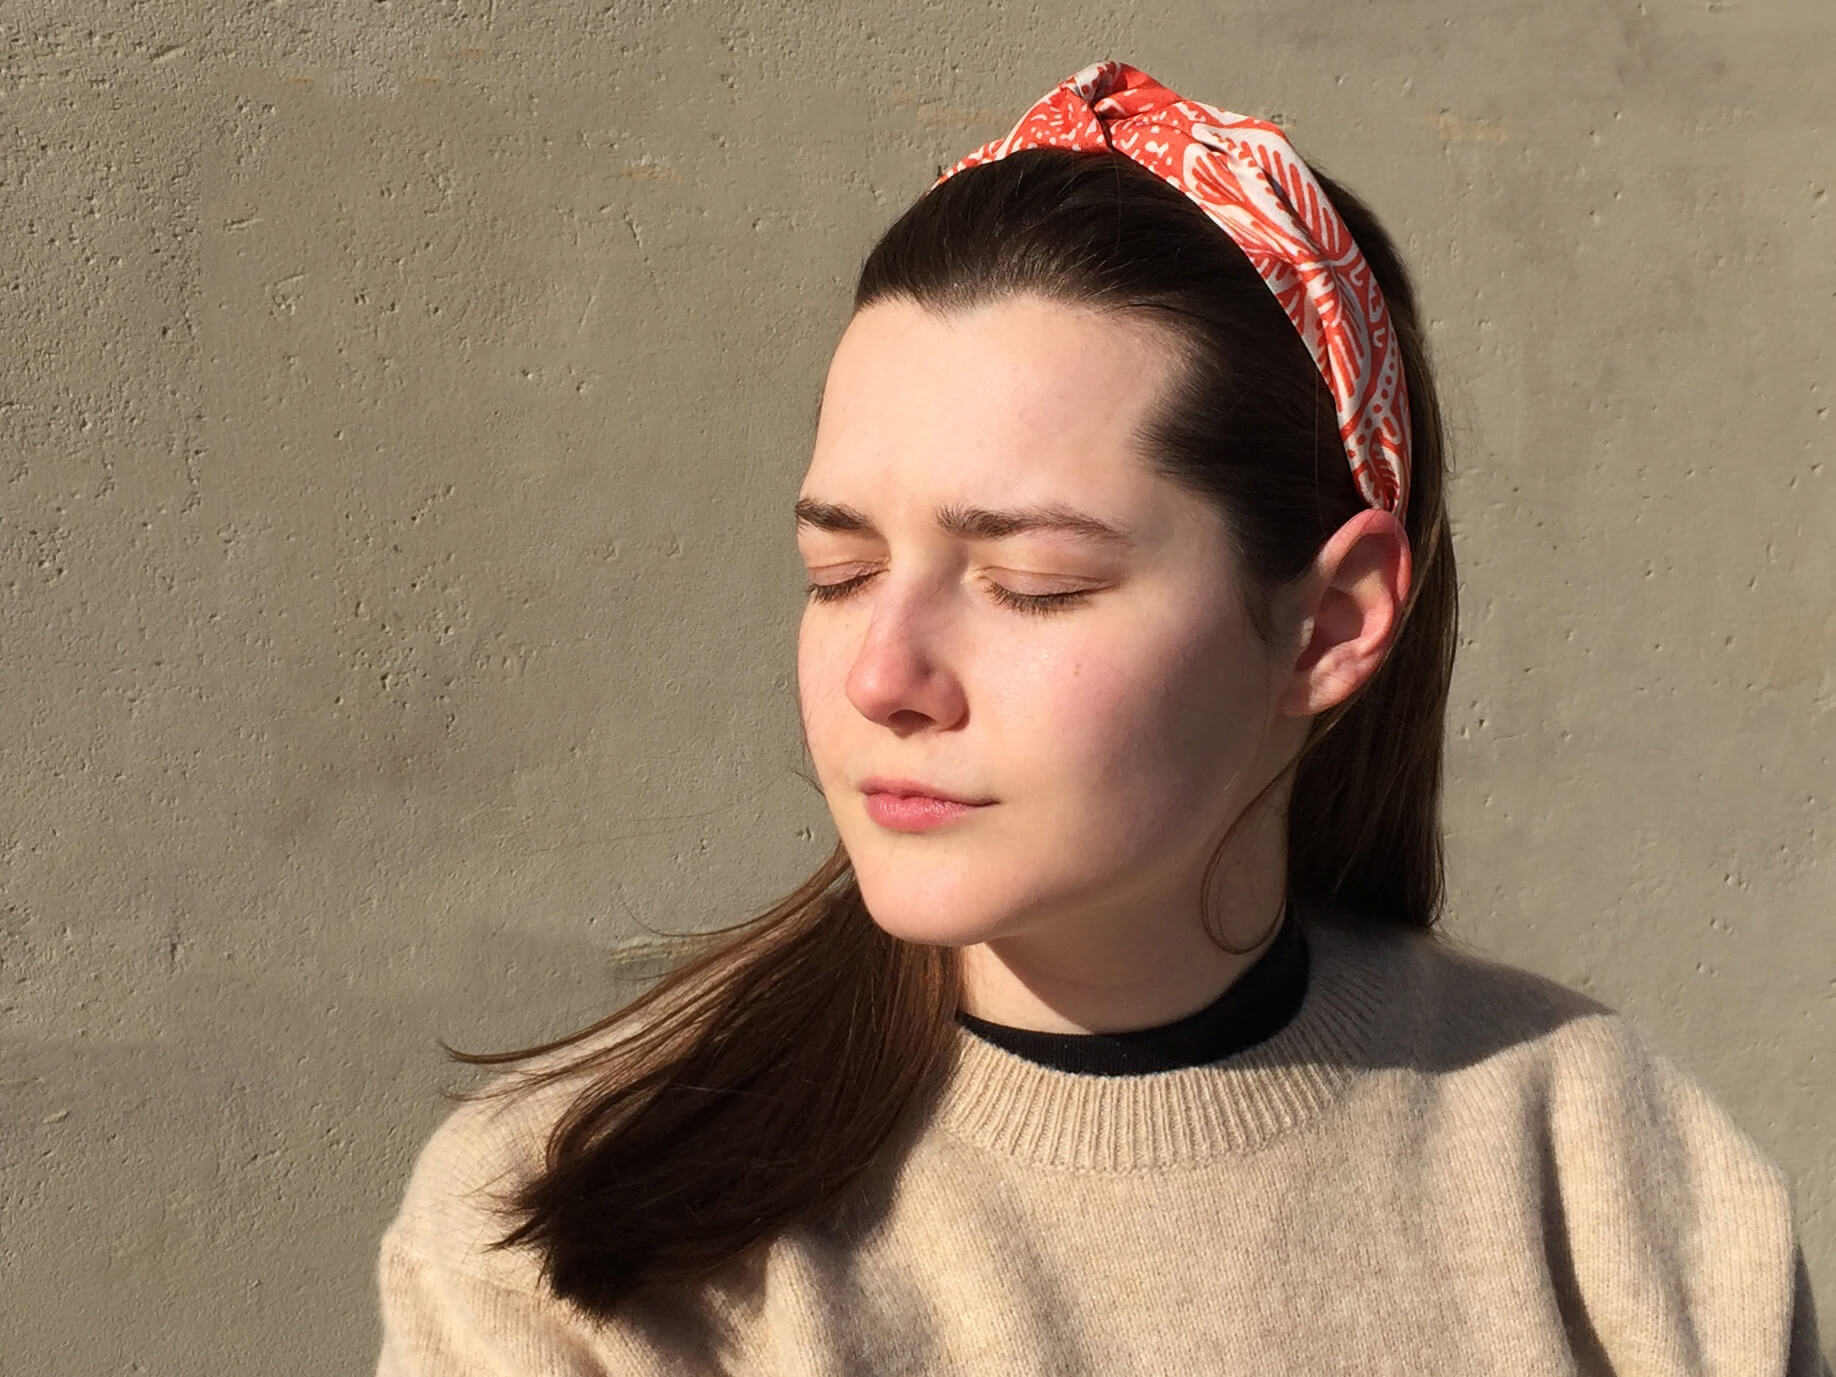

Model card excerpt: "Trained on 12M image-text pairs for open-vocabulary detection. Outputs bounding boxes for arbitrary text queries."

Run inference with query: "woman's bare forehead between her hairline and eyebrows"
[804,296,1177,509]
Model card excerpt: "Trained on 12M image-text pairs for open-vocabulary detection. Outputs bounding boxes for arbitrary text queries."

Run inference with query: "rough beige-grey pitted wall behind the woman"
[0,0,1836,1375]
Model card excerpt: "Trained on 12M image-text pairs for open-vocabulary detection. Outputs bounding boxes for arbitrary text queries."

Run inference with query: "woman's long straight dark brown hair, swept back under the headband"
[455,149,1456,1316]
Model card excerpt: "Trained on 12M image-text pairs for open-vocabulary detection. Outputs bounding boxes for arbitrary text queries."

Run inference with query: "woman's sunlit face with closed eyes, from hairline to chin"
[797,297,1298,969]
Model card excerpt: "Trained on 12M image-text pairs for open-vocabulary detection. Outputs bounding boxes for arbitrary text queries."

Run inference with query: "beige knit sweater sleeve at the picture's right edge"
[1548,1017,1829,1377]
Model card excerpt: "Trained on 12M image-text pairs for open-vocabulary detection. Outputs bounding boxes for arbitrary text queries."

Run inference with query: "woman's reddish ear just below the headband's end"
[1276,509,1410,718]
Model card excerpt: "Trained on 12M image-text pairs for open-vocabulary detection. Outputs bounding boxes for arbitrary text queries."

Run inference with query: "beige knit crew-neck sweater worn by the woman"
[378,918,1827,1377]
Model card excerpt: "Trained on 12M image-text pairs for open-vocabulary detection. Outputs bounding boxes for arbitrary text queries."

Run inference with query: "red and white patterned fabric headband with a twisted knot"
[938,62,1408,516]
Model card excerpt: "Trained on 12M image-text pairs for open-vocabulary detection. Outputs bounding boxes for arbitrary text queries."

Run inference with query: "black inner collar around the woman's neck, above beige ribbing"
[957,911,1307,1076]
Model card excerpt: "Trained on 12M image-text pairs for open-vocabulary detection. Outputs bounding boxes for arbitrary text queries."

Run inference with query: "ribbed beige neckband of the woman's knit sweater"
[933,911,1412,1171]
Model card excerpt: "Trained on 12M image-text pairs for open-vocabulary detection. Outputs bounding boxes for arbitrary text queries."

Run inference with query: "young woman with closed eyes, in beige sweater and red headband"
[380,62,1821,1377]
